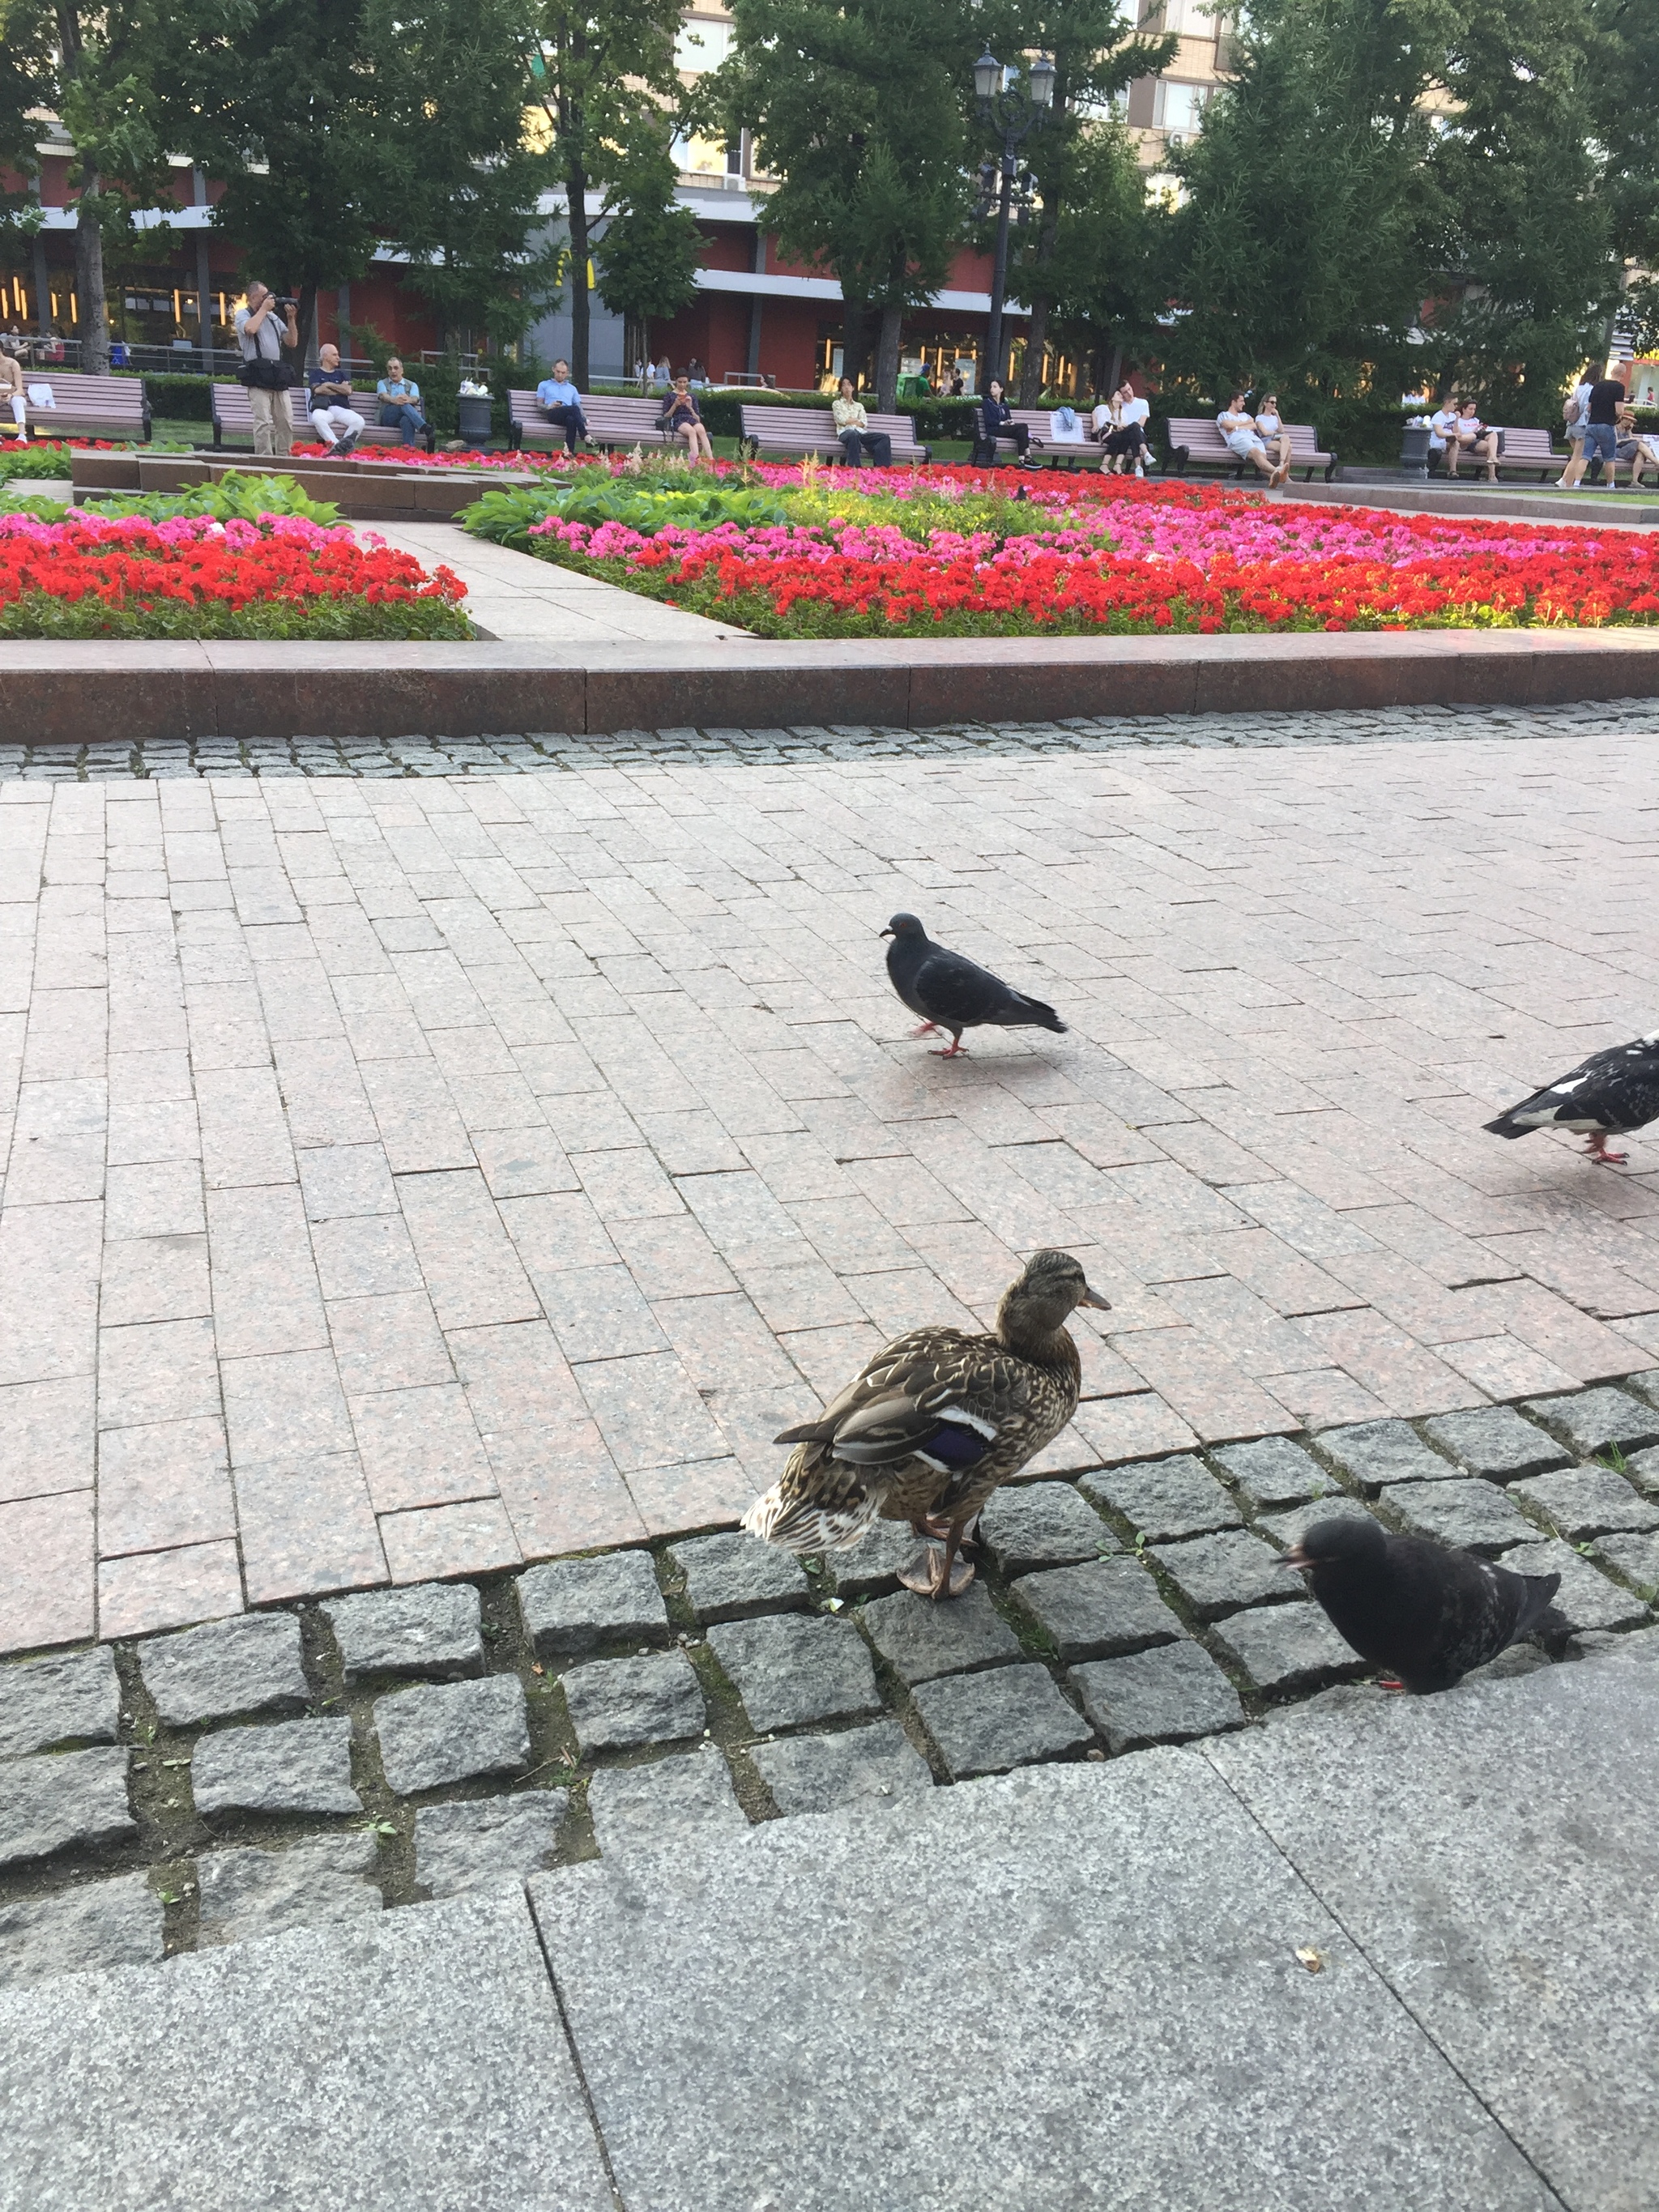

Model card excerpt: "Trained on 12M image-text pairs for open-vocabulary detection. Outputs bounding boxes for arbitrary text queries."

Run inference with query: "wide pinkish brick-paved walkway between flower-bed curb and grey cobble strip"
[0,705,1659,1652]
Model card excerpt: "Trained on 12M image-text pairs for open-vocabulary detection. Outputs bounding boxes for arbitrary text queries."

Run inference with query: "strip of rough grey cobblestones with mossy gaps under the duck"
[0,1397,1659,1986]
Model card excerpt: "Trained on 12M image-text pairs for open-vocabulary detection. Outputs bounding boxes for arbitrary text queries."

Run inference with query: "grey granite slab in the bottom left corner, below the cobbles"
[0,1894,615,2212]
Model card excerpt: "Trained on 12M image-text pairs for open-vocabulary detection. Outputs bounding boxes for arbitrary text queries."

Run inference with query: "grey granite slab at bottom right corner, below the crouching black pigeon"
[1203,1645,1659,2212]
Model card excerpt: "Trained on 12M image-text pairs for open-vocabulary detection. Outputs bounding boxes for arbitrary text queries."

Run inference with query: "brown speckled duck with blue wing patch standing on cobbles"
[744,1252,1111,1597]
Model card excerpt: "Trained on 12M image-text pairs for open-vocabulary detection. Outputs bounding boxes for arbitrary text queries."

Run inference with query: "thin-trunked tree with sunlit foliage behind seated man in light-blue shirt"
[522,0,686,385]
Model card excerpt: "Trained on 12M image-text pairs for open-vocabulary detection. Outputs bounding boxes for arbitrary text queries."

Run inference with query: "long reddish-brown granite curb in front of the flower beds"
[0,629,1659,745]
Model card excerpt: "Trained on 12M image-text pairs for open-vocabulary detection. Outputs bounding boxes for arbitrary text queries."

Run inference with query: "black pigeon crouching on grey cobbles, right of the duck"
[1286,1513,1562,1694]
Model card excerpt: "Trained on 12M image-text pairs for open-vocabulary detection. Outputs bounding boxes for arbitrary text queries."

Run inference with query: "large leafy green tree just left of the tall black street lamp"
[699,0,975,409]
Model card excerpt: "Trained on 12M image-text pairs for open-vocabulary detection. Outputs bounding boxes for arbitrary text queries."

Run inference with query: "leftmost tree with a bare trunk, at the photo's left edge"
[0,0,166,376]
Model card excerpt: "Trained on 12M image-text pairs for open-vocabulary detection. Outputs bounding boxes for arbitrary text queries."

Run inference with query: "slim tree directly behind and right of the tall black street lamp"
[975,0,1177,407]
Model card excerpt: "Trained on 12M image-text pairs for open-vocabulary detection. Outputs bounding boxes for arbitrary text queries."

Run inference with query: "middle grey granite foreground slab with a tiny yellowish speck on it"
[531,1743,1557,2212]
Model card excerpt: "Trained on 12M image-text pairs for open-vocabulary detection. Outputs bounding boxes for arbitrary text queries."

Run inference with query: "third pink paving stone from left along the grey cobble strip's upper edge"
[234,1451,387,1606]
